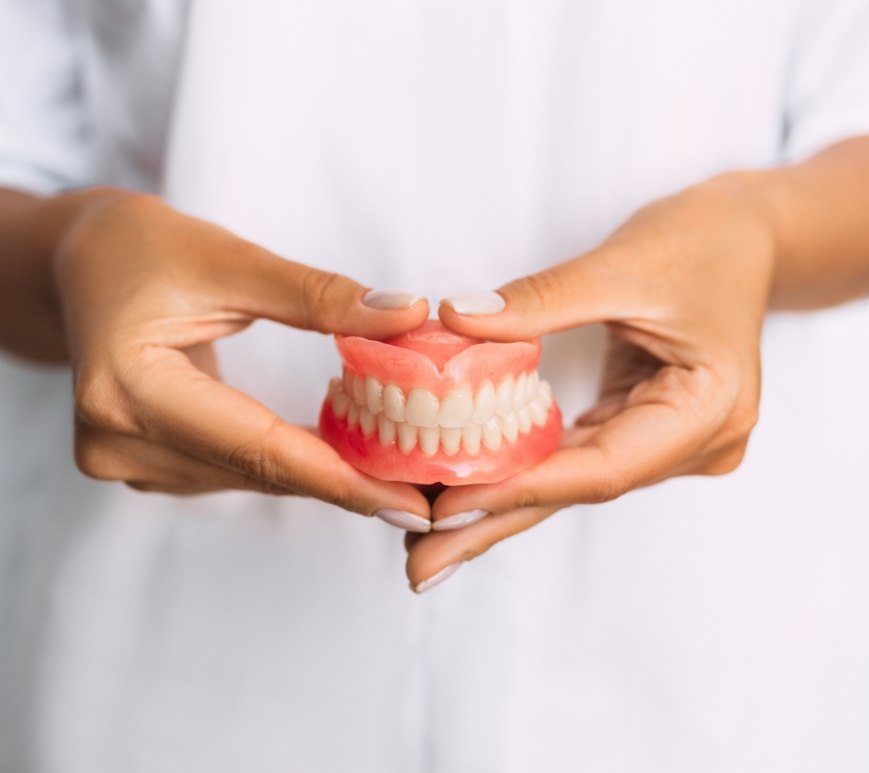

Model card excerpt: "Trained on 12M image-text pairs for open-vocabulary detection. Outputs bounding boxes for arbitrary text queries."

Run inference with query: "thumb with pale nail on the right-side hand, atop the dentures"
[438,255,628,341]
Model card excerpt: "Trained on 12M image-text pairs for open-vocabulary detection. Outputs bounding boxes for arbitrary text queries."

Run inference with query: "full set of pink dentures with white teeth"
[320,321,561,486]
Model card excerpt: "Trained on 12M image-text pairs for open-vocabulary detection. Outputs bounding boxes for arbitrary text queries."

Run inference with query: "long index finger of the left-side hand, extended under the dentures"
[124,347,429,519]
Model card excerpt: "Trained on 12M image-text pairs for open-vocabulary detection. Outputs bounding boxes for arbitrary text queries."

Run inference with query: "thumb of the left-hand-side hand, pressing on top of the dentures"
[226,250,428,338]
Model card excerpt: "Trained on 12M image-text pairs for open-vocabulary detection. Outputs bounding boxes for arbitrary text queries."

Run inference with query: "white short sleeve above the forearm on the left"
[0,0,90,193]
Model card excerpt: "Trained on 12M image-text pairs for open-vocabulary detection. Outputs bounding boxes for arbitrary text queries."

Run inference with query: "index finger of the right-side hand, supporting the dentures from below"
[432,368,729,523]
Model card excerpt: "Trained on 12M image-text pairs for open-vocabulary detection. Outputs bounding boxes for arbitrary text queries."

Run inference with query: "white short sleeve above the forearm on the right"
[782,0,869,162]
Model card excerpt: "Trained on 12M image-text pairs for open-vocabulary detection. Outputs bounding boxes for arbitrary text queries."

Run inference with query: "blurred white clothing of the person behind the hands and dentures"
[0,0,869,773]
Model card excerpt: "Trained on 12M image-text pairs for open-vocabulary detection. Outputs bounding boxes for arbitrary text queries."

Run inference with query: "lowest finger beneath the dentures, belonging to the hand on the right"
[405,507,558,592]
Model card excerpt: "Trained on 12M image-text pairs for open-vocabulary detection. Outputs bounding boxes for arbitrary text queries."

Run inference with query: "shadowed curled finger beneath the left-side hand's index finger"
[75,425,295,495]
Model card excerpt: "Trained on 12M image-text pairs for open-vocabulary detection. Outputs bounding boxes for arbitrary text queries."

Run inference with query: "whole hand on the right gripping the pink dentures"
[406,176,775,589]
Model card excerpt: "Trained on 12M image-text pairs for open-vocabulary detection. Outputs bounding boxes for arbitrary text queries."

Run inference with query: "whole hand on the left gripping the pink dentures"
[53,185,429,519]
